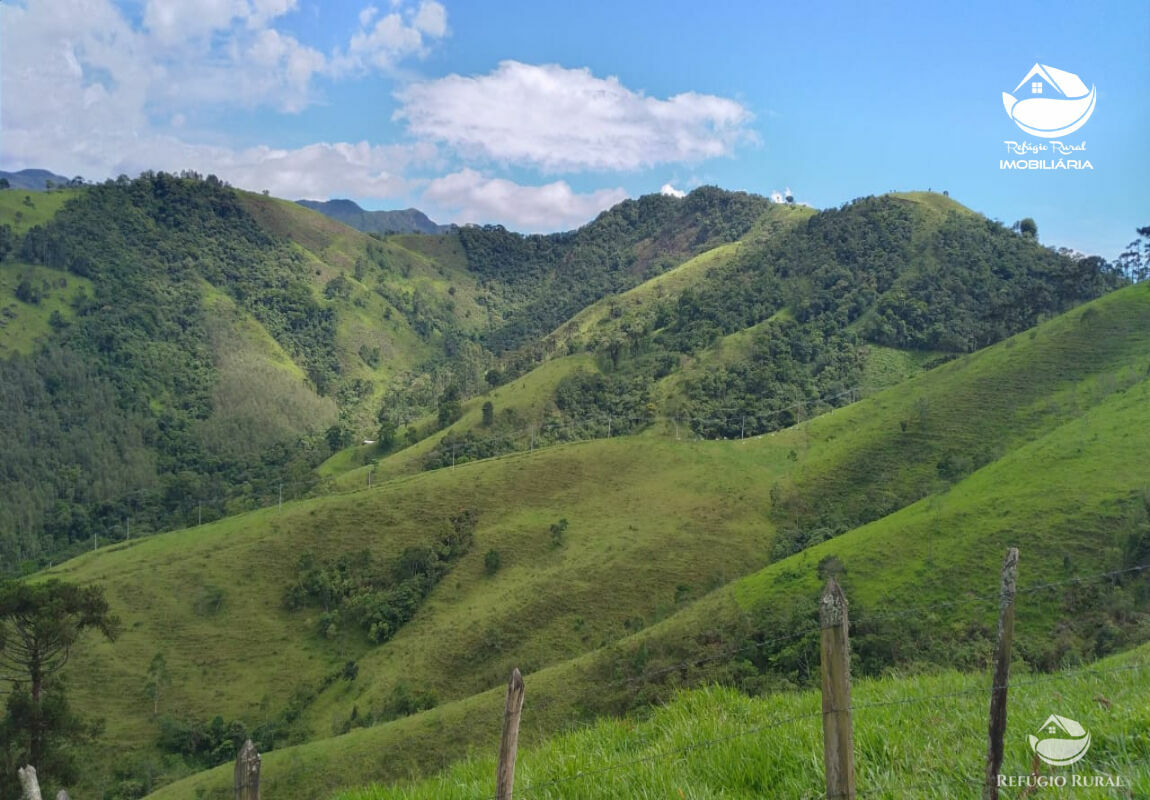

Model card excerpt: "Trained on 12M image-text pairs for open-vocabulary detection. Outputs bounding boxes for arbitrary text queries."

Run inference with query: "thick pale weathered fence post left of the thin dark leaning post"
[819,578,854,800]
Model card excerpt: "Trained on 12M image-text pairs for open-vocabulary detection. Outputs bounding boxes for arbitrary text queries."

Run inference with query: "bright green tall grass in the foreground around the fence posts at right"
[336,647,1150,800]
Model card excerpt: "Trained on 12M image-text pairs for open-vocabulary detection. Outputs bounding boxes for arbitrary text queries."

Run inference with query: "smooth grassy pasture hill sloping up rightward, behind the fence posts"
[22,286,1150,797]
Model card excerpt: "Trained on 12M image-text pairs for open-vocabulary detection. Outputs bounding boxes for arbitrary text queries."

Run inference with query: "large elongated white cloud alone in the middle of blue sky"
[396,61,753,171]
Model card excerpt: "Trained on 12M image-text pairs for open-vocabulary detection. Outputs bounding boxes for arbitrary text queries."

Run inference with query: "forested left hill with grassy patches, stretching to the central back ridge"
[0,174,795,571]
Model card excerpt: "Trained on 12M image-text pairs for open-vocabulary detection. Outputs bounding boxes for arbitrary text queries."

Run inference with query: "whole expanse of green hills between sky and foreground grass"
[0,174,1150,798]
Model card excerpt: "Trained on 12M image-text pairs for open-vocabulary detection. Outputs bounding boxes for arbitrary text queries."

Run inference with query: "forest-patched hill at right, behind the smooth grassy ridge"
[324,193,1122,484]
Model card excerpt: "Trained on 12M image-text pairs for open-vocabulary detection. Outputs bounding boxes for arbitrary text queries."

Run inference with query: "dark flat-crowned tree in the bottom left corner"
[0,580,120,779]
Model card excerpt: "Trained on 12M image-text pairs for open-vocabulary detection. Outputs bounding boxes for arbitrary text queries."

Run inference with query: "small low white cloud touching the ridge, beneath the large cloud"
[423,168,627,231]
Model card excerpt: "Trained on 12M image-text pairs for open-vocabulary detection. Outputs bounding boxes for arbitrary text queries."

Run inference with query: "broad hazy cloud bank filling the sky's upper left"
[0,0,445,197]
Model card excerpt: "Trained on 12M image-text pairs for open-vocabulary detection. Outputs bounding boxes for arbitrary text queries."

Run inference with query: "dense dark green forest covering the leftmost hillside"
[0,174,339,564]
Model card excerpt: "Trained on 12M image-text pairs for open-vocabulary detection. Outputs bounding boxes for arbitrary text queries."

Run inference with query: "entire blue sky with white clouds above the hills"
[0,0,1150,259]
